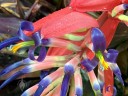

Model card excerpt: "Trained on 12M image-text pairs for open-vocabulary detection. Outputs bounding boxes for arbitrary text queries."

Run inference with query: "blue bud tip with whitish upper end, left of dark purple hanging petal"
[34,77,52,96]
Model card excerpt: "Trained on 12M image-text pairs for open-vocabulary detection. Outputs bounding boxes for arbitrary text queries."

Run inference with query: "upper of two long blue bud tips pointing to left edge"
[0,58,33,76]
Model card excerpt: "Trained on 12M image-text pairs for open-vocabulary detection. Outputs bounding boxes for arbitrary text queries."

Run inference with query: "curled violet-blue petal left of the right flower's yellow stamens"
[81,57,99,72]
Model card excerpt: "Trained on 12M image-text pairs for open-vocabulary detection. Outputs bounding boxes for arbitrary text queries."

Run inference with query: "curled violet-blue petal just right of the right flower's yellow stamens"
[104,49,119,63]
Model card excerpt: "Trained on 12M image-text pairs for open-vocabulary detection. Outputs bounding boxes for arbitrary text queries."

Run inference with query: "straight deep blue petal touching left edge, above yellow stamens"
[0,36,20,50]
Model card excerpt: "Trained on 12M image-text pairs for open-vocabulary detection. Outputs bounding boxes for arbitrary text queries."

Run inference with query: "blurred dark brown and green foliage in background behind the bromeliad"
[0,0,128,96]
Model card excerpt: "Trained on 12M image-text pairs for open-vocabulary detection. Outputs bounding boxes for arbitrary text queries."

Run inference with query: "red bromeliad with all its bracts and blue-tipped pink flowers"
[0,0,128,96]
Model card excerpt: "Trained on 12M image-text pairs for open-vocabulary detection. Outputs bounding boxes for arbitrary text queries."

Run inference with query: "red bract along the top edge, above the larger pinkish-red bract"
[70,0,121,12]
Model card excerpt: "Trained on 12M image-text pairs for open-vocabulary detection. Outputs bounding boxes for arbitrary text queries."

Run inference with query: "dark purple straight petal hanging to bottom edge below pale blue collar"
[60,74,71,96]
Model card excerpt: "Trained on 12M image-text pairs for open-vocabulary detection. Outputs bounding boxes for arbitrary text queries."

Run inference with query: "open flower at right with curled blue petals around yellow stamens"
[82,28,124,93]
